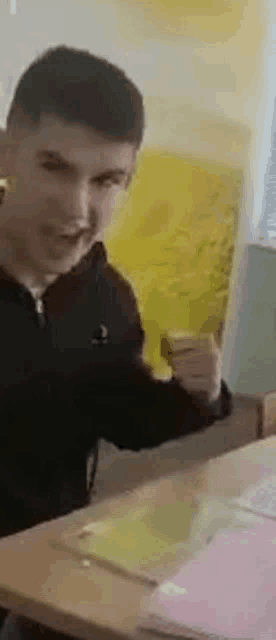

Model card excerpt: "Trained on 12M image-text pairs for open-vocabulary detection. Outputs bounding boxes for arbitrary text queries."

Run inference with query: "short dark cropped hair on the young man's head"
[7,45,145,148]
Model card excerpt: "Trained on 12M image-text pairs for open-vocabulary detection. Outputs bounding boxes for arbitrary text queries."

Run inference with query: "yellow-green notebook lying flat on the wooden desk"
[49,497,200,584]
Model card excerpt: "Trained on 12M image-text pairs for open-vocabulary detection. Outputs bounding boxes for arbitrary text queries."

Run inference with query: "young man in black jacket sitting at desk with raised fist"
[0,46,231,632]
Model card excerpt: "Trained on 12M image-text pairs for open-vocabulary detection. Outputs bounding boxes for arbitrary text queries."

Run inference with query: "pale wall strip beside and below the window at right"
[222,0,276,393]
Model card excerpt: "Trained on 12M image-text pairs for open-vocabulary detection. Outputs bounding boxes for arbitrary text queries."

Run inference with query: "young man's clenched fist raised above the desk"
[162,334,222,403]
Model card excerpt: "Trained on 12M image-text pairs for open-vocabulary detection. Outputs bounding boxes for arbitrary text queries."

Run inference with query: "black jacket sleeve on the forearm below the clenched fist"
[80,369,232,451]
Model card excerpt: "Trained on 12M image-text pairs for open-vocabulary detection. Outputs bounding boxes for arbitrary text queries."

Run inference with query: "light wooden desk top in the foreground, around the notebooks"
[0,436,276,640]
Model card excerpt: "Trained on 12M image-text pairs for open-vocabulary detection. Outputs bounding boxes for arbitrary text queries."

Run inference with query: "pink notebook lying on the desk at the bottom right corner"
[137,520,276,640]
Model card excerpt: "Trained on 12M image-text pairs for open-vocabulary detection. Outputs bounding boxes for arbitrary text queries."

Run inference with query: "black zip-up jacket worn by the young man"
[0,243,231,536]
